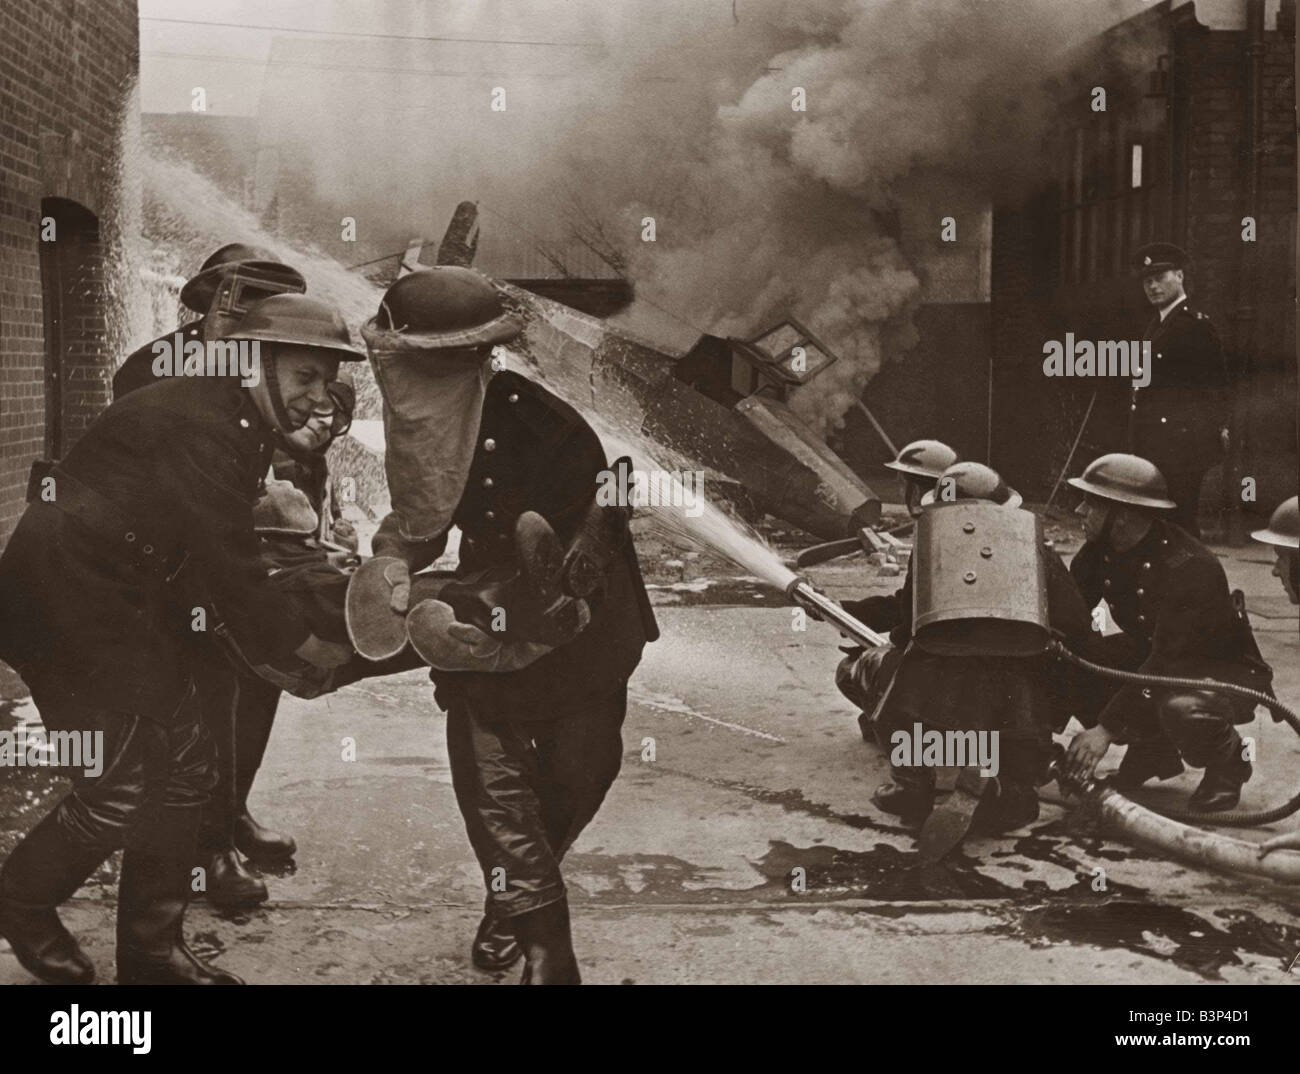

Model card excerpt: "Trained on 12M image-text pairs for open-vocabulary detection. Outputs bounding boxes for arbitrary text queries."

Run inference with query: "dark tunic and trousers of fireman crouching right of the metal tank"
[1070,519,1273,767]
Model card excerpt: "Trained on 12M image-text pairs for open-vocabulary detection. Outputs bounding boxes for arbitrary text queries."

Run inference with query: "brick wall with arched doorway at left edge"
[0,0,139,545]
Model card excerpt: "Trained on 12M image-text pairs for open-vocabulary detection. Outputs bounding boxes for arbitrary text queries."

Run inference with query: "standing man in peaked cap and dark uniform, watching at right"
[1128,242,1229,537]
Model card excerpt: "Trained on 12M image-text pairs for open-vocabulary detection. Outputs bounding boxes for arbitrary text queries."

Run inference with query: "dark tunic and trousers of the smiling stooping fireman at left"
[0,377,308,849]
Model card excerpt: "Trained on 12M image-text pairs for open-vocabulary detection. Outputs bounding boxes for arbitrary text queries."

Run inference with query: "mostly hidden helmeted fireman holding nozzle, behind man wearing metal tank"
[835,439,957,742]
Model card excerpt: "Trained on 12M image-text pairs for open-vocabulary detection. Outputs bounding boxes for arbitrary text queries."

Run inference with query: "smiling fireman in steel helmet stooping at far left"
[0,294,359,984]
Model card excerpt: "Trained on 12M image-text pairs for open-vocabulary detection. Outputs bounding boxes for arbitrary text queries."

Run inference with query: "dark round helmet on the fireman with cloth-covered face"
[372,265,523,347]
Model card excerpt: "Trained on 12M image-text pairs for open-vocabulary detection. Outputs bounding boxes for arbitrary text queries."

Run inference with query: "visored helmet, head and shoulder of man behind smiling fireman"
[113,242,307,399]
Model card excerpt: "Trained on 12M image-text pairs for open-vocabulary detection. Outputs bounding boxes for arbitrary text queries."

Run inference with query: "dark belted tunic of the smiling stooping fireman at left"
[0,377,308,719]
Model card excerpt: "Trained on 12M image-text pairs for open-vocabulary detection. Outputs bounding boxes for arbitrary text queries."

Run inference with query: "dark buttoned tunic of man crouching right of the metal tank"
[1070,519,1271,733]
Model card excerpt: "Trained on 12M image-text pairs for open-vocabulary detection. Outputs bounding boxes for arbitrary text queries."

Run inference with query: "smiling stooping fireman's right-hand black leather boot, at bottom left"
[117,807,243,984]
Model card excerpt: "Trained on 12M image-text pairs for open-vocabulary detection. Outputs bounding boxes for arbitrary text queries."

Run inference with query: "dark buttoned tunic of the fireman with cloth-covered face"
[372,372,659,720]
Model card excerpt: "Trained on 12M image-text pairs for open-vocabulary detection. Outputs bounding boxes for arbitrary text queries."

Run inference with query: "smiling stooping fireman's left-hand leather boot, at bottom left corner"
[0,809,108,984]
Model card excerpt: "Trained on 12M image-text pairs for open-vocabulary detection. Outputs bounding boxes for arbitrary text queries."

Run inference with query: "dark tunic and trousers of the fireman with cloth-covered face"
[373,372,658,915]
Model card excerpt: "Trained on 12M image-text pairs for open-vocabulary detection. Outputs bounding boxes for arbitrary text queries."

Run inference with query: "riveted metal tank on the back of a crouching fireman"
[913,501,1049,655]
